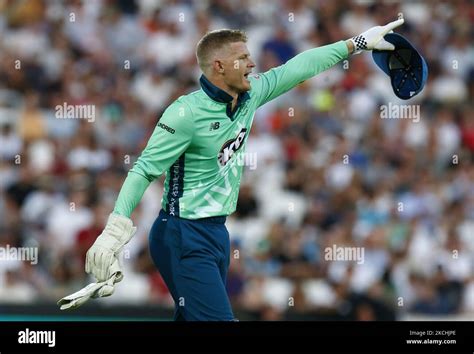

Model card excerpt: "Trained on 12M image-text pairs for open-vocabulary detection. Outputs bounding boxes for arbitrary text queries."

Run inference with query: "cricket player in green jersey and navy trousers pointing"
[85,18,403,321]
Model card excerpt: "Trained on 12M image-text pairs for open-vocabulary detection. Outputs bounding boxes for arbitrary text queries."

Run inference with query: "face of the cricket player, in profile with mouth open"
[221,42,255,93]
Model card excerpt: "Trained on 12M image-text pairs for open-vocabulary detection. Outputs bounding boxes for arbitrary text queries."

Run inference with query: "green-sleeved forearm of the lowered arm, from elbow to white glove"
[114,171,150,218]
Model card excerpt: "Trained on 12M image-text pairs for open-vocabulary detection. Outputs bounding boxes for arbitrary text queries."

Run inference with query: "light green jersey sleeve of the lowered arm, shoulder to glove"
[114,99,194,217]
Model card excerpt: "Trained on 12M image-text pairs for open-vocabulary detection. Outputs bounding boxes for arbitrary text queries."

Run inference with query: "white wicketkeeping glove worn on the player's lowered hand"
[85,214,137,282]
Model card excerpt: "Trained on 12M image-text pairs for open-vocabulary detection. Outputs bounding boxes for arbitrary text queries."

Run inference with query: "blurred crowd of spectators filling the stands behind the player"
[0,0,474,320]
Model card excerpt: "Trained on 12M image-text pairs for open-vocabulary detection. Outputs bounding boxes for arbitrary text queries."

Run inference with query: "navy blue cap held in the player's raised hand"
[372,33,428,100]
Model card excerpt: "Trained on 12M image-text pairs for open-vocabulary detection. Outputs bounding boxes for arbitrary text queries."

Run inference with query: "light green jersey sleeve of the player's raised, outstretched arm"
[252,41,349,107]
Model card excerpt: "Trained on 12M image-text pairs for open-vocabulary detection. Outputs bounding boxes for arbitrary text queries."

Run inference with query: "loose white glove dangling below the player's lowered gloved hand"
[58,260,123,310]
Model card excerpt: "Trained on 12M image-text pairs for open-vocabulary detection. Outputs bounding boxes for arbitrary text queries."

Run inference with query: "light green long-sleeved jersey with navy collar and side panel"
[114,41,348,219]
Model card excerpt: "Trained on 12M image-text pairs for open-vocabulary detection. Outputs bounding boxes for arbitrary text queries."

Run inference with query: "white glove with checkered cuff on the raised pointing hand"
[350,17,405,53]
